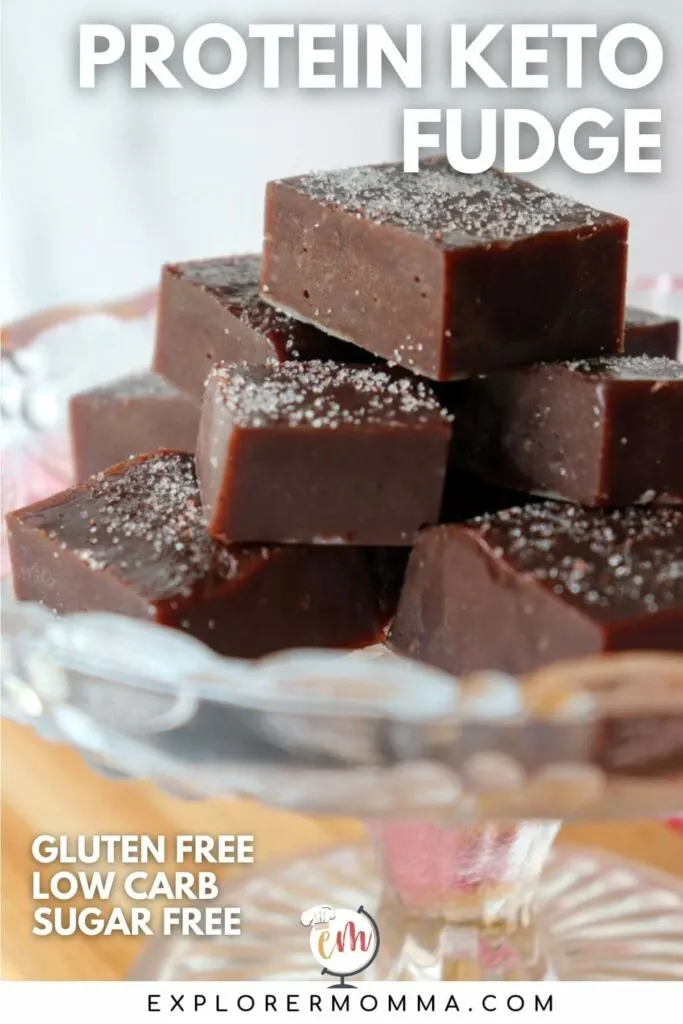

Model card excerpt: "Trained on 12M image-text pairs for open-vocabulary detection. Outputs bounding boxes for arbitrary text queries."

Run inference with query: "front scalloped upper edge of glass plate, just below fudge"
[1,581,683,729]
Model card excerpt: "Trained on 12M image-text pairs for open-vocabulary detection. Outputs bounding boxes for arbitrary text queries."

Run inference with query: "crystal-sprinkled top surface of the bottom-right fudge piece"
[466,501,683,620]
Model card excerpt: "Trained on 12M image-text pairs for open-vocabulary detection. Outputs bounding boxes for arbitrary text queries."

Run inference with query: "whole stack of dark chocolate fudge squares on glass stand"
[9,159,683,674]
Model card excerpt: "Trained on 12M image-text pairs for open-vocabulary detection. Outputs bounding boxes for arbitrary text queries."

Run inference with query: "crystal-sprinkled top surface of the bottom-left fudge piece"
[12,452,268,600]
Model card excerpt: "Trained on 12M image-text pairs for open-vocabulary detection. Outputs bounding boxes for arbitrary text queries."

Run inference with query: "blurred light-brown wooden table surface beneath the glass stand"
[0,723,683,981]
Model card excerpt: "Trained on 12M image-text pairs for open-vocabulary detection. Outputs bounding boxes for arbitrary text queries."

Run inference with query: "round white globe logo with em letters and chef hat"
[301,904,380,988]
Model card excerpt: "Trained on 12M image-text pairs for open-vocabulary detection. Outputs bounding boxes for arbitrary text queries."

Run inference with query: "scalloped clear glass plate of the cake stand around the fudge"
[2,275,683,817]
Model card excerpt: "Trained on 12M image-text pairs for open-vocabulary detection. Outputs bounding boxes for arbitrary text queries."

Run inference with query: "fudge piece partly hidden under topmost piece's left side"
[154,256,370,400]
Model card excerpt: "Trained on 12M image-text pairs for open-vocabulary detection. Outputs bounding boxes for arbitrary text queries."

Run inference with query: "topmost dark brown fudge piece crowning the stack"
[262,158,628,380]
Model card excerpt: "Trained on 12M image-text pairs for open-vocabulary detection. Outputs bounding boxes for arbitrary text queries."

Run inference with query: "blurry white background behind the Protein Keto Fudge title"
[0,0,683,322]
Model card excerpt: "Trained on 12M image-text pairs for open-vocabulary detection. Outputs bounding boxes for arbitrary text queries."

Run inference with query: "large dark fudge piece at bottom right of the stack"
[390,502,683,685]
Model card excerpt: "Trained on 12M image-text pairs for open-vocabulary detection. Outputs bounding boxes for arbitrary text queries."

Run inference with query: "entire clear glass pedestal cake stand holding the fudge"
[2,279,683,981]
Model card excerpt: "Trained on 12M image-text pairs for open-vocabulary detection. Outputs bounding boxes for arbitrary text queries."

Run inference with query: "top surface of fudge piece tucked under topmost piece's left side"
[166,255,317,357]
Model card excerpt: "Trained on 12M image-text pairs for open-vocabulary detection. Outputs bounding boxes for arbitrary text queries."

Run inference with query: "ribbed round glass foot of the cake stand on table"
[130,845,683,983]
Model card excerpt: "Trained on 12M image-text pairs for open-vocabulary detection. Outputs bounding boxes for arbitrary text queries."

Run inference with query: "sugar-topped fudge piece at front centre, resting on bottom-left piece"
[197,361,451,546]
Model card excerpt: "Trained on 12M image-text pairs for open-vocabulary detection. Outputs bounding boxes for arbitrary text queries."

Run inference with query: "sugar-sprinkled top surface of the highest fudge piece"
[278,158,625,249]
